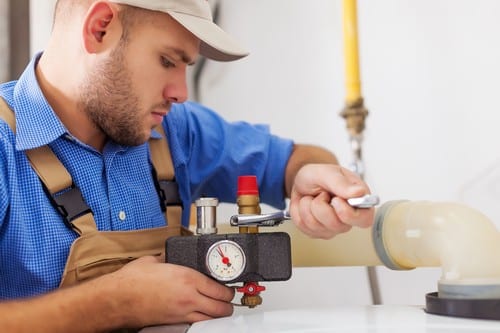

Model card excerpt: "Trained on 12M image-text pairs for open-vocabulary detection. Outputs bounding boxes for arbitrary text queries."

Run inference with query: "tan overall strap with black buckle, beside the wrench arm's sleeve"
[149,124,183,227]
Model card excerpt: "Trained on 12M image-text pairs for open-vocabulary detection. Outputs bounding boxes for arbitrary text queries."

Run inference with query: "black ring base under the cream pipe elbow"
[425,292,500,320]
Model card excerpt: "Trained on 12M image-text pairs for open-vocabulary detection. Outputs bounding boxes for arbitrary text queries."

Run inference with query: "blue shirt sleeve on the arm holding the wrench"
[167,102,293,209]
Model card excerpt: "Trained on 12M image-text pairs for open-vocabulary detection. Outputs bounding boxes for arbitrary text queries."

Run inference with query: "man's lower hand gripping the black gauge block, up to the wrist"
[109,257,234,327]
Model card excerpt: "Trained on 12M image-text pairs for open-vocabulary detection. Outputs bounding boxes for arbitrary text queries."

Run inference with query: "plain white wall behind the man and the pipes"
[32,0,500,307]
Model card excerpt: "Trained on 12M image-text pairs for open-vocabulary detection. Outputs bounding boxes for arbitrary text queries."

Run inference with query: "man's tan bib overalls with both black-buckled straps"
[0,98,191,287]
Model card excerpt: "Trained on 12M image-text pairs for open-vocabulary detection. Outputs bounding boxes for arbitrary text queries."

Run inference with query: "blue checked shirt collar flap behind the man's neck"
[14,53,161,150]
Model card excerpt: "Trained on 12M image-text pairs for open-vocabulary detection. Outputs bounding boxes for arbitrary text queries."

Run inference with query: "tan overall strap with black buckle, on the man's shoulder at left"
[0,98,97,235]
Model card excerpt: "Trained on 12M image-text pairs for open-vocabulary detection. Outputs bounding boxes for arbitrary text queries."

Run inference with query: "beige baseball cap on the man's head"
[111,0,248,61]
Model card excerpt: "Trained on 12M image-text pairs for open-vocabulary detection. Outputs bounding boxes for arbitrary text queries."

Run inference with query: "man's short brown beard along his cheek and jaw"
[79,45,149,146]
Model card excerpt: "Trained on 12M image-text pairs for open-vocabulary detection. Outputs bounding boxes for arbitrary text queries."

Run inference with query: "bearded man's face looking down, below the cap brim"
[79,13,199,146]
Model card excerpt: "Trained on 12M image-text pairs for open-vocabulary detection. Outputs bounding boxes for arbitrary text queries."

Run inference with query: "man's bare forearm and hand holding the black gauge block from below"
[0,257,234,333]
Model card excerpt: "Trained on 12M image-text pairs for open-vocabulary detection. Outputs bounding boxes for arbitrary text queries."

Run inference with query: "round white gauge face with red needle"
[205,240,246,281]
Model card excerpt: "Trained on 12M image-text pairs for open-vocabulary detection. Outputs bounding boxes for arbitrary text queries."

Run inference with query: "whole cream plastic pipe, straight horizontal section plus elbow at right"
[219,201,500,299]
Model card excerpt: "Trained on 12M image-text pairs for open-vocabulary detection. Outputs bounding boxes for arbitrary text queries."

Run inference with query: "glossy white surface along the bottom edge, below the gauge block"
[188,304,500,333]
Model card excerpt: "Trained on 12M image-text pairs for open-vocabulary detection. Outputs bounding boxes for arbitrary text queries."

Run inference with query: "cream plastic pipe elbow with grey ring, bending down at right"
[373,201,500,298]
